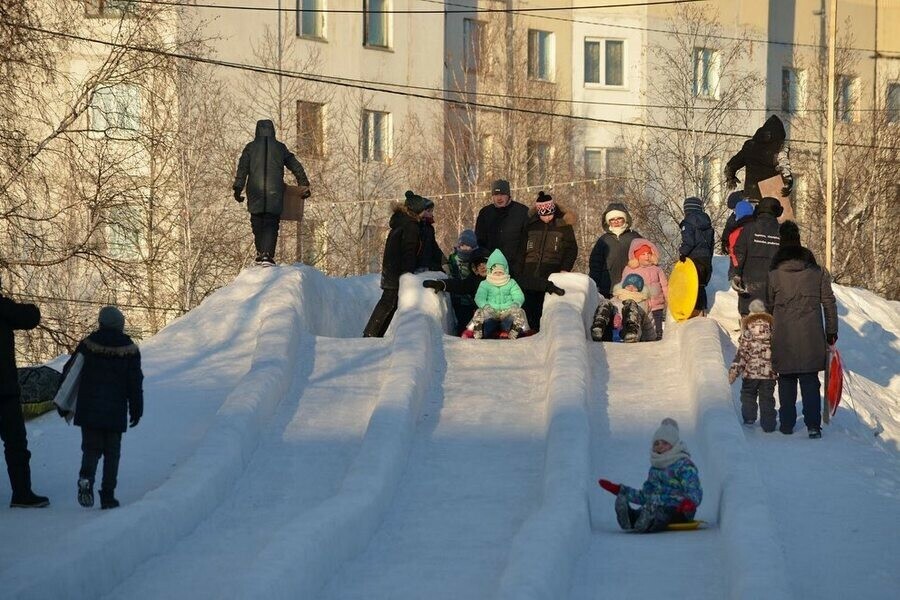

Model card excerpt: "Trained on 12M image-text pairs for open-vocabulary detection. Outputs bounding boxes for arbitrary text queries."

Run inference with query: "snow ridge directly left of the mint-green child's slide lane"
[236,275,448,599]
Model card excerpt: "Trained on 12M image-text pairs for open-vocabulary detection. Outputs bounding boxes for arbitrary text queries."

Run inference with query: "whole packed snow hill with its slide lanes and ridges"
[0,260,900,600]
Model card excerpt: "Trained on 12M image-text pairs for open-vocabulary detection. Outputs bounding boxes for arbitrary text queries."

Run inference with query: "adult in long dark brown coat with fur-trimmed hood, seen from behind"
[767,221,838,438]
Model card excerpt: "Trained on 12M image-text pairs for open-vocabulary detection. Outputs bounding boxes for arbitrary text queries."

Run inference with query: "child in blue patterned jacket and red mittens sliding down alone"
[600,418,703,533]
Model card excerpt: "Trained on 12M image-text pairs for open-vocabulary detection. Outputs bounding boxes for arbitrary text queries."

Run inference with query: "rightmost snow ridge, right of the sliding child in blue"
[666,319,790,599]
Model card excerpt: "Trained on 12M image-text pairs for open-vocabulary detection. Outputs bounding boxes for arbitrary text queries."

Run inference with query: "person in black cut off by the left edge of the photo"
[0,284,50,508]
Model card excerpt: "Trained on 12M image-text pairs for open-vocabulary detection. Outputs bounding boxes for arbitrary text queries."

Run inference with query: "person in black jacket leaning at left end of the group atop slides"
[363,191,430,337]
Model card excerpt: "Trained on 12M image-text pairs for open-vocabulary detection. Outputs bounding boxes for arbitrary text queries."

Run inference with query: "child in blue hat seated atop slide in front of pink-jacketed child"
[591,273,662,343]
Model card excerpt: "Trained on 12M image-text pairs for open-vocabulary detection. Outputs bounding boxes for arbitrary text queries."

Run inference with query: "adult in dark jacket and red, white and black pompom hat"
[516,191,578,331]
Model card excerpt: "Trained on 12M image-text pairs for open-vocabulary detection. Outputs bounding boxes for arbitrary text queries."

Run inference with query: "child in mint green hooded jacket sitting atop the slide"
[466,250,528,339]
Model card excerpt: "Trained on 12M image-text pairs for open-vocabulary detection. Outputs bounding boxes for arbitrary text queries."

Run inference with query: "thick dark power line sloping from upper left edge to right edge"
[7,21,900,150]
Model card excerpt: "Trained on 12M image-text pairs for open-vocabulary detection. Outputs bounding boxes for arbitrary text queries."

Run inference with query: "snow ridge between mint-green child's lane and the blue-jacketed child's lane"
[498,273,597,600]
